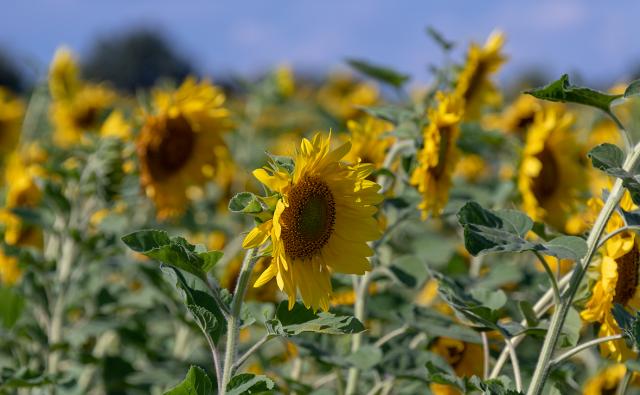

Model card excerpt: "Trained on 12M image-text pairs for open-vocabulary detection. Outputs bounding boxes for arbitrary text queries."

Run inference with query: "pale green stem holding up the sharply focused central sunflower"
[220,248,258,395]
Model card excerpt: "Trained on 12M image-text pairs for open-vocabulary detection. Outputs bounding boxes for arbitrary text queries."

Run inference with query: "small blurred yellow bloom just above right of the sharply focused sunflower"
[344,116,395,169]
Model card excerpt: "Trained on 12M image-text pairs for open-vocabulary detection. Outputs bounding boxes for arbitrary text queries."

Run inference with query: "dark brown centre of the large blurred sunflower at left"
[147,115,195,179]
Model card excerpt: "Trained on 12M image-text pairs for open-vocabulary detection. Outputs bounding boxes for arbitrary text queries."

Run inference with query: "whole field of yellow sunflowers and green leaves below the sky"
[0,31,640,395]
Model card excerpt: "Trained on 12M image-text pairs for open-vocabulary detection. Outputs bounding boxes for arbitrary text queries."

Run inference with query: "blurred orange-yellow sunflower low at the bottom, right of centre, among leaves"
[429,337,484,395]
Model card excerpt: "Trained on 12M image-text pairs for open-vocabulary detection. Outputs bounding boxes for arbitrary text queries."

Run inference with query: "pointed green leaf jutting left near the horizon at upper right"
[525,74,622,113]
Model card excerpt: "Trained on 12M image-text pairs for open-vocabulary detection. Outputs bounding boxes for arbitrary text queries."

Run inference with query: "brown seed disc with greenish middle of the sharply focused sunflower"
[280,177,336,260]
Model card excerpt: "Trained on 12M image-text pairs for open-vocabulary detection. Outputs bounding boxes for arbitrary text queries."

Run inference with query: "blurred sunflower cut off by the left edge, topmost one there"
[0,87,25,162]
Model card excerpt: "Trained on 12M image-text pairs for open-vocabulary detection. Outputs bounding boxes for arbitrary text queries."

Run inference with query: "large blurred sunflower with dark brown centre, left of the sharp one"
[136,78,230,219]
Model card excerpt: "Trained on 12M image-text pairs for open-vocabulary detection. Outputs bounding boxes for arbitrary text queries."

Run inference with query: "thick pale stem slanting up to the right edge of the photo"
[527,144,640,395]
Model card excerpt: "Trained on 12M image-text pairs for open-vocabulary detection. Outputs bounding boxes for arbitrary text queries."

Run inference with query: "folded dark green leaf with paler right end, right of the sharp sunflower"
[458,202,587,261]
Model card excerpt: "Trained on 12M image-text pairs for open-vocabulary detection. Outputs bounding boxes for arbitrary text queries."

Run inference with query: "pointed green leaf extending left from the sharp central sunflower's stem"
[122,230,222,283]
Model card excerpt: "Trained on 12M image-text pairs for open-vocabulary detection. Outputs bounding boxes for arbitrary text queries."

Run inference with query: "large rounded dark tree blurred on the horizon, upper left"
[83,30,193,92]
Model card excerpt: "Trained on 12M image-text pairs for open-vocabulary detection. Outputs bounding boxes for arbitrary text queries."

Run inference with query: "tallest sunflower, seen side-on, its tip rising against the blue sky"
[455,32,507,120]
